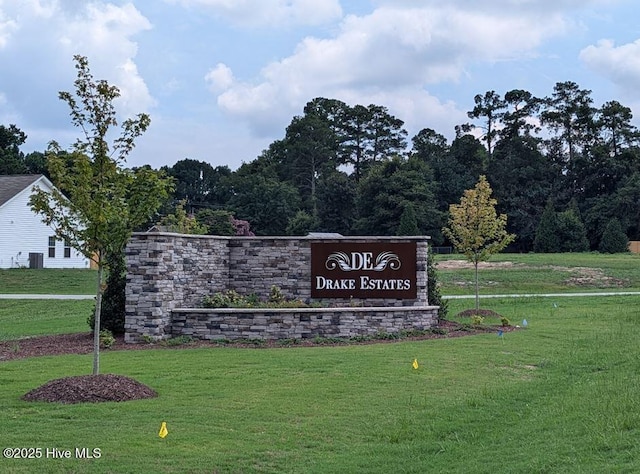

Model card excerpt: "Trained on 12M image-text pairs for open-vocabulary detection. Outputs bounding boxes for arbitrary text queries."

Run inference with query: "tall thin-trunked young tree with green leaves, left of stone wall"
[30,55,172,375]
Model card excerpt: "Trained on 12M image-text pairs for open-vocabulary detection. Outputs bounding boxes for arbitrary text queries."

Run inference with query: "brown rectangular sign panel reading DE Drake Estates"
[311,241,417,299]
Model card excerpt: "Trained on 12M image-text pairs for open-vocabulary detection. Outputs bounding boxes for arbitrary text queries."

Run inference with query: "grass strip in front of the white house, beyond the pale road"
[0,268,97,295]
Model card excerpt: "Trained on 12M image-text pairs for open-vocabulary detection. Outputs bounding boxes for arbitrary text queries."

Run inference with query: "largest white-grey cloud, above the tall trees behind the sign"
[218,2,572,139]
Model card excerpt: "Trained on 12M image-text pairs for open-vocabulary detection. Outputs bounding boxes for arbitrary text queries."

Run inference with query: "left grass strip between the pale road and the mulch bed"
[0,299,94,341]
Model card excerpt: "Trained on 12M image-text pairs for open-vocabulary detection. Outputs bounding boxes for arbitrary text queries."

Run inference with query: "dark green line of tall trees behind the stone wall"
[0,82,640,252]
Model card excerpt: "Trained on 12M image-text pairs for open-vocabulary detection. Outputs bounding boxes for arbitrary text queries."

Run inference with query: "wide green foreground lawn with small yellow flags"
[0,255,640,473]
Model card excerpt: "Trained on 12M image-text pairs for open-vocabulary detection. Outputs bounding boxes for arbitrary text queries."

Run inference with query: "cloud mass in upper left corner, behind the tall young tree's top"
[0,0,155,139]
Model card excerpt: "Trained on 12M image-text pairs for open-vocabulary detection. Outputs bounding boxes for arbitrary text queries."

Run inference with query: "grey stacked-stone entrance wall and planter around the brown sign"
[125,233,438,342]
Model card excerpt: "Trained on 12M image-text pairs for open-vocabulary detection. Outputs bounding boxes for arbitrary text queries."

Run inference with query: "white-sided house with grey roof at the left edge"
[0,175,90,268]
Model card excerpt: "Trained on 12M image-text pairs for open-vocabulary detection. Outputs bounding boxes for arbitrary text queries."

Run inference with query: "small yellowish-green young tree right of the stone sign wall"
[442,176,516,310]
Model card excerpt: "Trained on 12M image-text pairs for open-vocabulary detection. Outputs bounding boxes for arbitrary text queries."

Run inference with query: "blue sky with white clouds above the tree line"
[0,0,640,169]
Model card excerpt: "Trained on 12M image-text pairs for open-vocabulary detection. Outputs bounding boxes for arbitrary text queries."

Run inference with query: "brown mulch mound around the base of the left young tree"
[22,374,158,404]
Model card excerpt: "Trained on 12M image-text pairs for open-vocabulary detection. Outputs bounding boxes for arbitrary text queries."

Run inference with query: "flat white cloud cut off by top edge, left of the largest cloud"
[165,0,342,27]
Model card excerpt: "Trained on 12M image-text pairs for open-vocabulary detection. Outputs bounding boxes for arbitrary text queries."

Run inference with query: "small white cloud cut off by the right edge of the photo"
[580,39,640,95]
